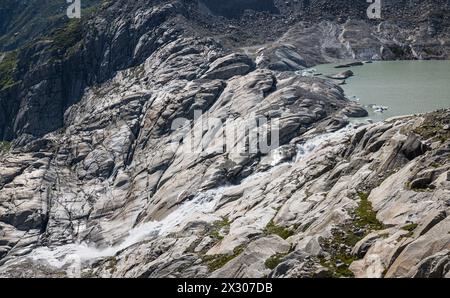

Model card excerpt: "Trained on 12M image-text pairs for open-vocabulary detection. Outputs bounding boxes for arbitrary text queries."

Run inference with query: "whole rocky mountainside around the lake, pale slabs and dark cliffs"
[0,0,450,277]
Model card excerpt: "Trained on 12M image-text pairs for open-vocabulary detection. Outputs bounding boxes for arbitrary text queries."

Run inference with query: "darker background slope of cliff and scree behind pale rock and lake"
[0,0,449,145]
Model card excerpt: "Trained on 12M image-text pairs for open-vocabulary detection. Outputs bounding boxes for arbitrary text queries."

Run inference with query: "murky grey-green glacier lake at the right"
[313,60,450,121]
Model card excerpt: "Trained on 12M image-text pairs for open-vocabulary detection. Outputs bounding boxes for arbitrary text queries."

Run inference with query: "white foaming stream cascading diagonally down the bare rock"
[29,124,354,268]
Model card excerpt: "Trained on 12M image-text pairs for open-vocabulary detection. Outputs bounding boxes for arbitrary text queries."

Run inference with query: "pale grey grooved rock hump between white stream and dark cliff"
[1,18,352,276]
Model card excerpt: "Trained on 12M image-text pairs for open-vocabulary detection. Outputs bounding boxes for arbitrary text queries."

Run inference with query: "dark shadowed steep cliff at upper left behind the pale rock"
[0,1,184,141]
